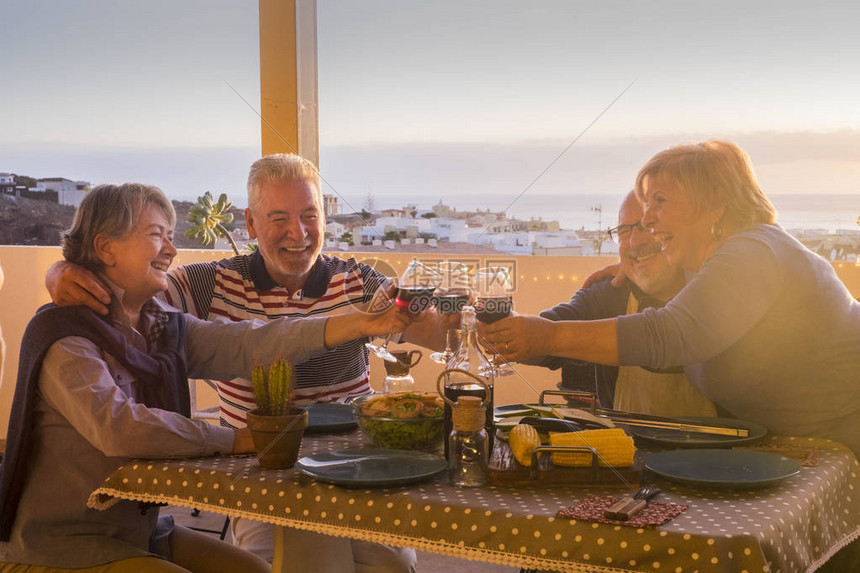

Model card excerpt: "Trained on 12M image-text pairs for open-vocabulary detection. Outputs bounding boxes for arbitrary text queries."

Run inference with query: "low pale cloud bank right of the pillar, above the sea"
[321,130,860,203]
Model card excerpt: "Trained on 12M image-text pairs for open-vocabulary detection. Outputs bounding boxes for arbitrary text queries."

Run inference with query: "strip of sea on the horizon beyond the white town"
[436,191,860,232]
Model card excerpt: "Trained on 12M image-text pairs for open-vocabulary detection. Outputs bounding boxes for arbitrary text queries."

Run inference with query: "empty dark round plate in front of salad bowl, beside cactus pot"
[296,448,447,487]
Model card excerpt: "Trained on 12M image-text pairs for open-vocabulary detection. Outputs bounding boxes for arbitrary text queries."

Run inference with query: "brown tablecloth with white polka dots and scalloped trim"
[89,432,860,573]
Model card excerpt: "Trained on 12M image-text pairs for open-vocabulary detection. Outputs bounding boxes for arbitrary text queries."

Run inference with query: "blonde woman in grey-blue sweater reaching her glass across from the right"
[482,141,860,456]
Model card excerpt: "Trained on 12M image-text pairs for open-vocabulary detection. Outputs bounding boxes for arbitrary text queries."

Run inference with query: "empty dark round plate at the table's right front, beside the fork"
[645,449,800,488]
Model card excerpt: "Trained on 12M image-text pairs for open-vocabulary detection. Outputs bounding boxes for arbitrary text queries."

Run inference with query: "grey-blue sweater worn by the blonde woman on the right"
[618,224,860,455]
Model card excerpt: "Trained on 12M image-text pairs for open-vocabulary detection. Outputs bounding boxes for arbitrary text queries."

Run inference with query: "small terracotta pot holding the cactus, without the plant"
[247,408,308,470]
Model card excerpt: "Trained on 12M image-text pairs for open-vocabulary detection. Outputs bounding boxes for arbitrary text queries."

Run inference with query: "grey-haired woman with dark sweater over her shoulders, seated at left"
[0,184,409,572]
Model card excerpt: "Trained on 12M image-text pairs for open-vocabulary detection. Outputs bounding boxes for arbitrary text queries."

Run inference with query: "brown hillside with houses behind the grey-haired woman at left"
[0,195,242,249]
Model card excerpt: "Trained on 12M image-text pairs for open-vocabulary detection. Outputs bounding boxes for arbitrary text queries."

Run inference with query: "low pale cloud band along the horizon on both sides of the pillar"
[0,130,860,209]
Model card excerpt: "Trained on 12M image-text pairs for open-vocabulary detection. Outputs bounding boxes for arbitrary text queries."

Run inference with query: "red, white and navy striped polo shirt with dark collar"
[165,251,385,428]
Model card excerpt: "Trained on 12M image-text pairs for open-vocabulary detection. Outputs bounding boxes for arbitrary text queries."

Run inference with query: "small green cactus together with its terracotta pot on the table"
[247,360,308,469]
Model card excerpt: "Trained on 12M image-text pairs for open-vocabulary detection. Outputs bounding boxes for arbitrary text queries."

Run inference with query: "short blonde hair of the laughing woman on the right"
[634,139,776,232]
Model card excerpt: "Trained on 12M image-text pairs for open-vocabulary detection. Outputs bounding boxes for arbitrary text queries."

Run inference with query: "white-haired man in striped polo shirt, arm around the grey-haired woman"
[46,154,444,573]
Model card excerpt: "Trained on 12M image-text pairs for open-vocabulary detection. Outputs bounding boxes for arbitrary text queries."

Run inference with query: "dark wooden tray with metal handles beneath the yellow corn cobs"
[489,439,642,488]
